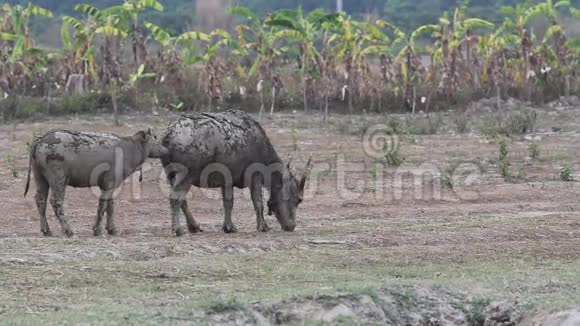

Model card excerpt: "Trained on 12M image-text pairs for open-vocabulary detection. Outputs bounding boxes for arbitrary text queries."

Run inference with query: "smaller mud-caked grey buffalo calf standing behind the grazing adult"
[24,129,166,237]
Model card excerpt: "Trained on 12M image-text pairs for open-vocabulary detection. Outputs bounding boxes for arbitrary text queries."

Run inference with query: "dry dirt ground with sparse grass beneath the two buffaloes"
[0,109,580,325]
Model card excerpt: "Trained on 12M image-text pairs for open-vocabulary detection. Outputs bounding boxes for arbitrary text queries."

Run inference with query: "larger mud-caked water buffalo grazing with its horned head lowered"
[160,110,311,236]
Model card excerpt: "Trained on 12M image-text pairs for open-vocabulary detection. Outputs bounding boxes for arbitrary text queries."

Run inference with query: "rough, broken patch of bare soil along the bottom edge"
[206,287,516,326]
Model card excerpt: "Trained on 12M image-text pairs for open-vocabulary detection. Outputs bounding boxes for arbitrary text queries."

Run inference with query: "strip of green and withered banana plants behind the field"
[0,0,580,123]
